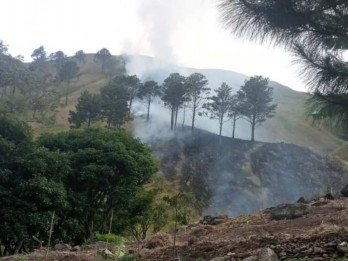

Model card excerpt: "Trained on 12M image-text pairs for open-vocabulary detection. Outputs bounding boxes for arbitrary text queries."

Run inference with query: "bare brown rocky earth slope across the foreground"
[0,198,348,261]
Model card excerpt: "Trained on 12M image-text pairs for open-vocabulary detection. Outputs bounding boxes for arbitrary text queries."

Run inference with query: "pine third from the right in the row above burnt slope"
[204,83,232,142]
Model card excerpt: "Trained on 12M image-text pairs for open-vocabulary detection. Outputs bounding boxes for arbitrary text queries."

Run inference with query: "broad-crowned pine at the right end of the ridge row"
[238,76,277,141]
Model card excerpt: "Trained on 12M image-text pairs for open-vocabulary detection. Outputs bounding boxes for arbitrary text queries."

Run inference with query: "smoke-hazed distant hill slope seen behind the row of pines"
[125,55,342,153]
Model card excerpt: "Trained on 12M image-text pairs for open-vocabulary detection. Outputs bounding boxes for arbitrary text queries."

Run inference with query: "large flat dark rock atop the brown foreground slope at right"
[270,203,310,220]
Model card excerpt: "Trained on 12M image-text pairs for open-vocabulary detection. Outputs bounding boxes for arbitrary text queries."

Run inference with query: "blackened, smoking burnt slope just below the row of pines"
[144,127,348,216]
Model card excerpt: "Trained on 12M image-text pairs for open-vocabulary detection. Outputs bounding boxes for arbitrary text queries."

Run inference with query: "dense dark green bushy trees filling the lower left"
[0,117,157,254]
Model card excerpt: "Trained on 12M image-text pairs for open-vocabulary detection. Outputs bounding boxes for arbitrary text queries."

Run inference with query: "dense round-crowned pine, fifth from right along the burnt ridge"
[161,73,189,130]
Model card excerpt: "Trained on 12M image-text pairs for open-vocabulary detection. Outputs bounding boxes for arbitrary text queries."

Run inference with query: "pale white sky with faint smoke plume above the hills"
[0,0,306,91]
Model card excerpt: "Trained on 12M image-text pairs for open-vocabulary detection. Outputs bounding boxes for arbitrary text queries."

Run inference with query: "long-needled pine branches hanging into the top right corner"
[220,0,348,134]
